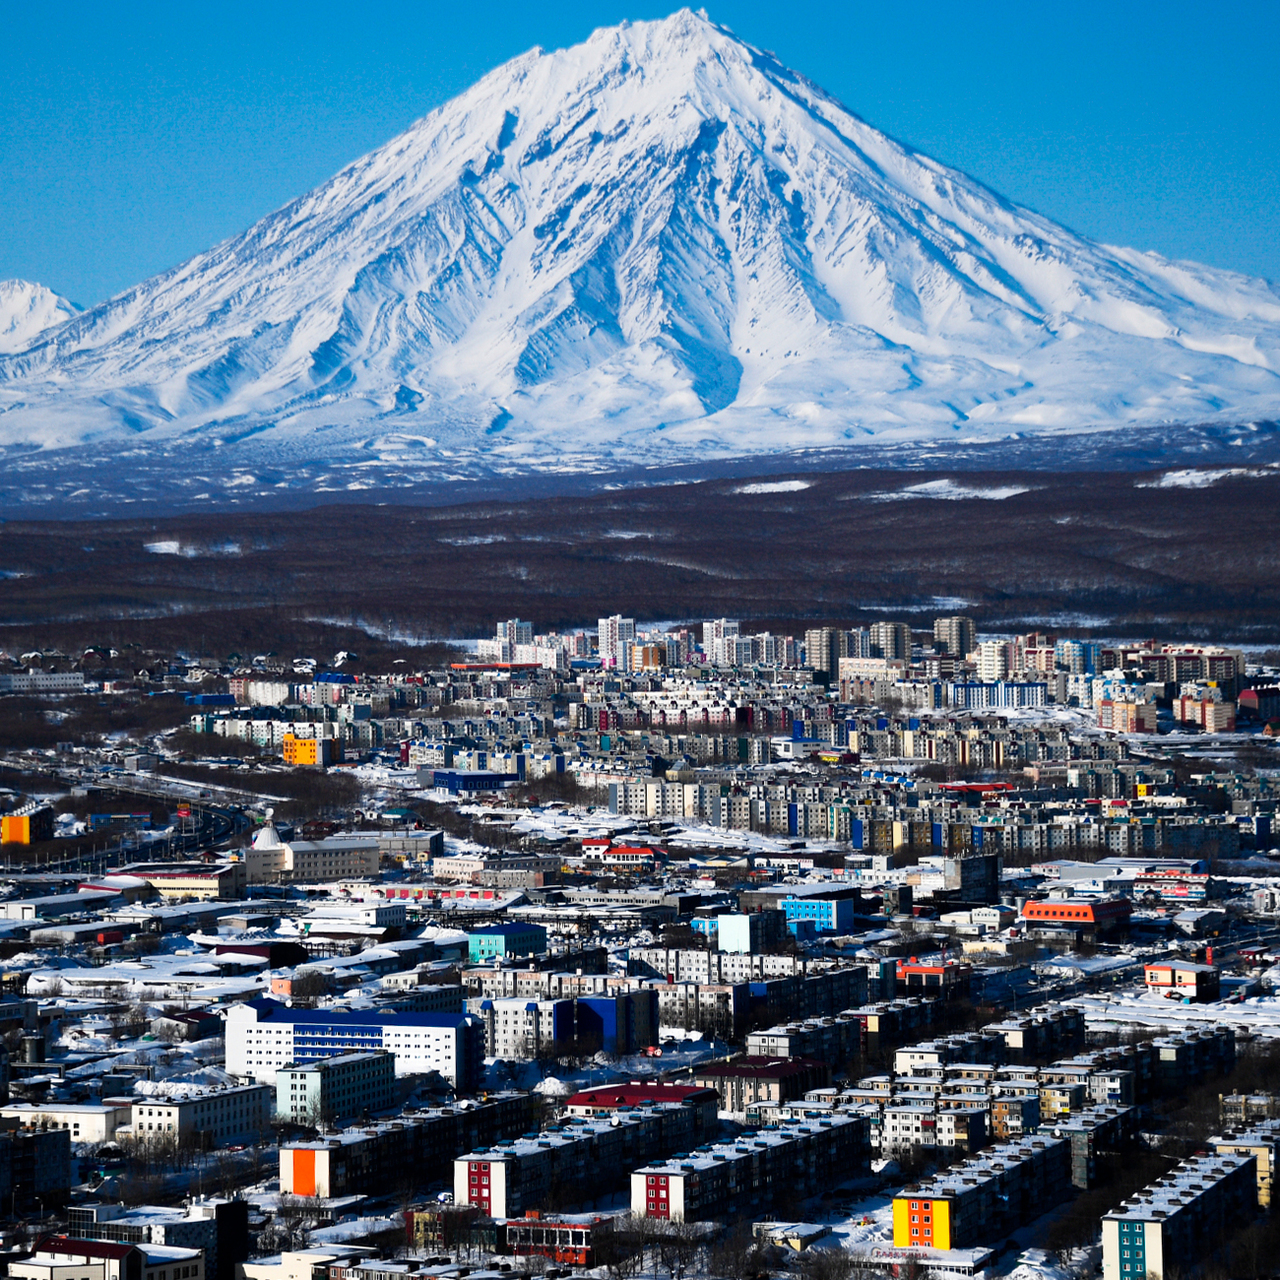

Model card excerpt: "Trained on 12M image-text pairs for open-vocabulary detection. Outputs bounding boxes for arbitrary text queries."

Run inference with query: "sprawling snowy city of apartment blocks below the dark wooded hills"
[0,614,1280,1280]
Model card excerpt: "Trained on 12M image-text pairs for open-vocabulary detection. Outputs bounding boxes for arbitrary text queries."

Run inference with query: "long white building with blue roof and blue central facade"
[227,1000,484,1089]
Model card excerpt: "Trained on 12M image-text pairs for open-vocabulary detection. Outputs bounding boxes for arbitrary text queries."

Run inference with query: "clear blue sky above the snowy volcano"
[0,0,1280,305]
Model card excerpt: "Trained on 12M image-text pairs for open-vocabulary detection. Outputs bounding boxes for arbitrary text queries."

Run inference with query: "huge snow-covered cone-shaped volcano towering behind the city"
[0,10,1280,496]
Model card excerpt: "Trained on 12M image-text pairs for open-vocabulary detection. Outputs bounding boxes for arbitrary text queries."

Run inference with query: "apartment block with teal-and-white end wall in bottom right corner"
[1102,1152,1257,1280]
